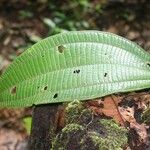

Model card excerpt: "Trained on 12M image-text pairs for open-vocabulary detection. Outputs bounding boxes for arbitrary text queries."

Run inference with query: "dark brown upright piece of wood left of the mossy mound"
[29,104,59,150]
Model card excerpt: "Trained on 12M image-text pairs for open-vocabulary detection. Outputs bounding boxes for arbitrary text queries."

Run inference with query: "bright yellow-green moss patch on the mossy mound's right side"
[90,119,127,150]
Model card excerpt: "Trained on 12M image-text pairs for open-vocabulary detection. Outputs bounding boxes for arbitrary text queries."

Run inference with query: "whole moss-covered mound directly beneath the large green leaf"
[52,102,127,150]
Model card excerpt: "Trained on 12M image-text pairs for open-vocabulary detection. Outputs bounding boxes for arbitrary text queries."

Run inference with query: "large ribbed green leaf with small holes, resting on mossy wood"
[0,31,150,107]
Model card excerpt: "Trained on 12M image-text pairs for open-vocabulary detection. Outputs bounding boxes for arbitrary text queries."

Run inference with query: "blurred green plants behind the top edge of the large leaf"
[43,0,105,34]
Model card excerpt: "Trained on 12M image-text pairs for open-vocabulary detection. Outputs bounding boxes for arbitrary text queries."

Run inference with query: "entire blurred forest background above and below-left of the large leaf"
[0,0,150,150]
